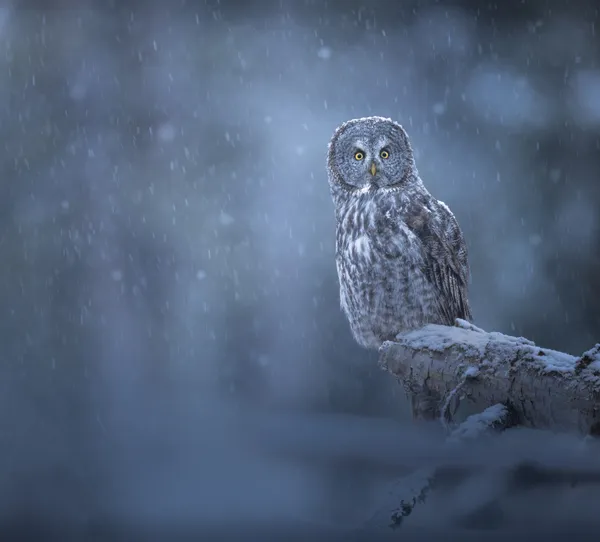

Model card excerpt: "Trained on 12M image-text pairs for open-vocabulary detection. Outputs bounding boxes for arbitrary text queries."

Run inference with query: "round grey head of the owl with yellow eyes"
[327,117,415,190]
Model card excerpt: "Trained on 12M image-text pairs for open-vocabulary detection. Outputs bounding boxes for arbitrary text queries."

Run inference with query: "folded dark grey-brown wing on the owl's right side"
[404,198,472,325]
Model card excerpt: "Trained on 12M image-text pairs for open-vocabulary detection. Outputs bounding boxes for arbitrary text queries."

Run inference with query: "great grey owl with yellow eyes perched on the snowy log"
[327,117,471,348]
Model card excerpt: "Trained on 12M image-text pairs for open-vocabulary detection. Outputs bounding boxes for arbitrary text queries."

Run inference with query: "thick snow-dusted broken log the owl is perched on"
[379,320,600,435]
